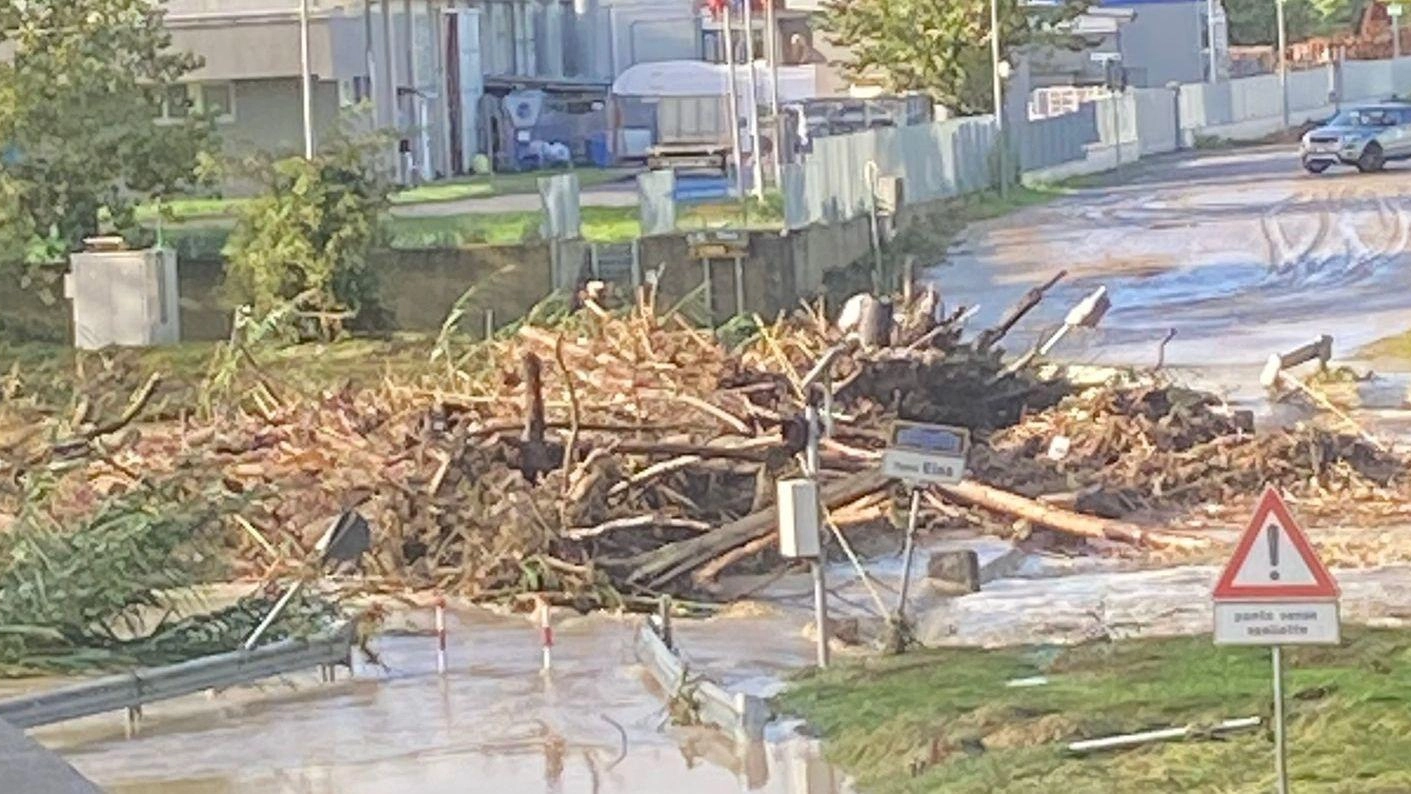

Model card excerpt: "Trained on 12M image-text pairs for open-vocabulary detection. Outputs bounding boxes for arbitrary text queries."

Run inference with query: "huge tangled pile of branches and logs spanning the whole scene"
[0,273,1405,608]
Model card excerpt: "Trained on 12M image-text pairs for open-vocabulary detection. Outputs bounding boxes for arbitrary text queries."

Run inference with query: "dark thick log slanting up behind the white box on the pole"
[605,468,890,588]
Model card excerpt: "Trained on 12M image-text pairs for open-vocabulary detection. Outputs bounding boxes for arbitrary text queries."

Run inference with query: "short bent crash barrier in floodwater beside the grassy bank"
[636,616,772,743]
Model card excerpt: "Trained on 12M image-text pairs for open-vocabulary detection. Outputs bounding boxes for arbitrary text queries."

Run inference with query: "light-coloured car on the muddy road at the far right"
[1300,103,1411,173]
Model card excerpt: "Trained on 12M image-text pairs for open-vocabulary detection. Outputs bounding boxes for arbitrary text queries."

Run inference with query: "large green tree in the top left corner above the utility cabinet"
[0,0,214,270]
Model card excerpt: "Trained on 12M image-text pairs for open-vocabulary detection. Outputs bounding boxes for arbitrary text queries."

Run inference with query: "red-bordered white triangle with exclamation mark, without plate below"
[1213,488,1338,599]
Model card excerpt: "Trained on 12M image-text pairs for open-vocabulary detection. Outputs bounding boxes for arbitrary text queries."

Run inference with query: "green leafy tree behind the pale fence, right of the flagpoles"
[823,0,1089,113]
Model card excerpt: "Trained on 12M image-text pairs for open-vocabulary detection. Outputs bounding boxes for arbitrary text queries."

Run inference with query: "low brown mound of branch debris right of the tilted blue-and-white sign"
[983,377,1408,515]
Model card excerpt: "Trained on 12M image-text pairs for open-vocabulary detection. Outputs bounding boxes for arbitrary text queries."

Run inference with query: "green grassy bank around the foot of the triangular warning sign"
[777,629,1411,794]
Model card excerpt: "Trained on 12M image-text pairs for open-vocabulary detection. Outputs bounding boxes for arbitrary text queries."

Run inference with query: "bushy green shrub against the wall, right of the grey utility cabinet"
[226,141,389,337]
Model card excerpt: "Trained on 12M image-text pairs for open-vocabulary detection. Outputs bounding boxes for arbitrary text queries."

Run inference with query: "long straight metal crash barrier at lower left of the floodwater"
[0,622,353,728]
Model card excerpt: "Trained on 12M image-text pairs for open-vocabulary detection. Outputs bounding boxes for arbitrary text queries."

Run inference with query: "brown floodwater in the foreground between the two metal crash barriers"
[34,612,847,794]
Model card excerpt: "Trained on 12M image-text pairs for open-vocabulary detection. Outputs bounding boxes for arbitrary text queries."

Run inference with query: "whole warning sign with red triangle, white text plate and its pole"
[1212,488,1342,794]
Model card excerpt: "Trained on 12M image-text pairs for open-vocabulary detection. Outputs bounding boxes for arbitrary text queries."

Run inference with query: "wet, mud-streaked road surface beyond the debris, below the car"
[927,147,1411,365]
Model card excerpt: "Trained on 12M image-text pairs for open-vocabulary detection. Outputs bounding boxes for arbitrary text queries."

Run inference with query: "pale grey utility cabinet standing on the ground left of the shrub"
[63,237,181,350]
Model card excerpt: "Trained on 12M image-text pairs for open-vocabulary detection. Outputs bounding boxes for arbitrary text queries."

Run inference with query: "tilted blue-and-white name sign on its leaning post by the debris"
[882,422,971,626]
